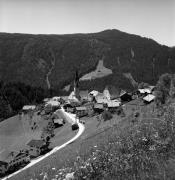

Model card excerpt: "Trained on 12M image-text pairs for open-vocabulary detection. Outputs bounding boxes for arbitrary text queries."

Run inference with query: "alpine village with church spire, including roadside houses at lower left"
[0,73,155,176]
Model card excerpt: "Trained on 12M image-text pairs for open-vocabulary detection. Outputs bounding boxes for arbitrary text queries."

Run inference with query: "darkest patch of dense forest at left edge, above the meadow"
[0,81,52,121]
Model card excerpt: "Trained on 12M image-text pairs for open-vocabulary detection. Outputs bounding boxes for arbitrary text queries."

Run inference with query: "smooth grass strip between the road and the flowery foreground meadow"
[6,101,163,180]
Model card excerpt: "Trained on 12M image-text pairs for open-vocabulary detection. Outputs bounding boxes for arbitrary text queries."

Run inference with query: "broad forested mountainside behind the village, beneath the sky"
[0,30,175,89]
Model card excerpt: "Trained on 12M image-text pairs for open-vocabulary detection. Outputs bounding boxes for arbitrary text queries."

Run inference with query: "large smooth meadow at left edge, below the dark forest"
[0,115,41,157]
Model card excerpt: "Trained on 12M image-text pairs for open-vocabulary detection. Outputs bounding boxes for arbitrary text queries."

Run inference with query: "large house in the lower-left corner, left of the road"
[0,150,30,174]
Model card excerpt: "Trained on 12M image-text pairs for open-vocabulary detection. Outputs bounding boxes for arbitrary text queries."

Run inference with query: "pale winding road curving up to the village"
[2,108,85,180]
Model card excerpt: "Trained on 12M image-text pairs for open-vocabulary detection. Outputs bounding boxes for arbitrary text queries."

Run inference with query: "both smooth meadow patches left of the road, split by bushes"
[0,109,75,159]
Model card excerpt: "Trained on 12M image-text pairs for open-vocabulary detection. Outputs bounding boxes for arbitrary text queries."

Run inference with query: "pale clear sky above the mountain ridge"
[0,0,175,46]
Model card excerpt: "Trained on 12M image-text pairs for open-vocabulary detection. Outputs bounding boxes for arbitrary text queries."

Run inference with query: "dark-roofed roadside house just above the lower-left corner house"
[27,139,49,157]
